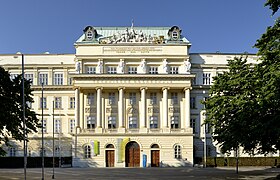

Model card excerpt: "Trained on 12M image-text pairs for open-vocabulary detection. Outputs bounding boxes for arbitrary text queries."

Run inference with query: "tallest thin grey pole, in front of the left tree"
[21,54,27,180]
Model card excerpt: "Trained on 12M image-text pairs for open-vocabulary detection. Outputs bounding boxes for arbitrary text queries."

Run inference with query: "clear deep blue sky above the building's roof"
[0,0,279,54]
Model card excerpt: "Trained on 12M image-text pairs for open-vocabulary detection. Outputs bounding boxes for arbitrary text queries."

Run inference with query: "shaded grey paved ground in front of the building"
[0,167,280,180]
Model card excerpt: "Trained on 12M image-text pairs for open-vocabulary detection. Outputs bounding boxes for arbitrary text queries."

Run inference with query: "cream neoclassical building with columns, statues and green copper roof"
[0,25,257,167]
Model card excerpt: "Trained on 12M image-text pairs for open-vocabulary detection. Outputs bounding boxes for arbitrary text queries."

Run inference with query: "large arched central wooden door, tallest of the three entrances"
[125,142,140,167]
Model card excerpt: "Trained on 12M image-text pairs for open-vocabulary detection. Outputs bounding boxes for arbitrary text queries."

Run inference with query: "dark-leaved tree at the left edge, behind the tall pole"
[0,67,39,156]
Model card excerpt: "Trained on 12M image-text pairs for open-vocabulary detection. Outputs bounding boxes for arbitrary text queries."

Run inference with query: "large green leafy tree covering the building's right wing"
[203,0,280,154]
